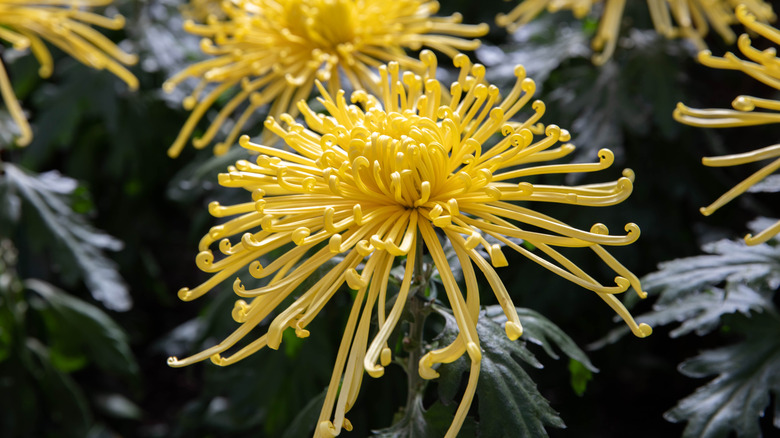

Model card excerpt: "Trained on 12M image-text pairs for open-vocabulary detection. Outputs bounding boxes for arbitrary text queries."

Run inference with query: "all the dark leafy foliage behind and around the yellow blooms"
[0,0,780,438]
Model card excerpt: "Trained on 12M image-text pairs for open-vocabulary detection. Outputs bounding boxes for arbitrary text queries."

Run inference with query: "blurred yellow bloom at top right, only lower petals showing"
[496,0,776,64]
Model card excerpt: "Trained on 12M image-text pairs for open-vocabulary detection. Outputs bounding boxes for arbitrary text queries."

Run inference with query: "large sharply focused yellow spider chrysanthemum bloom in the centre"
[169,51,652,437]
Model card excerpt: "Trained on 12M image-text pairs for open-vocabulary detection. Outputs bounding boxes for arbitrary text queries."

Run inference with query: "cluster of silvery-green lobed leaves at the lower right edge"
[608,229,780,438]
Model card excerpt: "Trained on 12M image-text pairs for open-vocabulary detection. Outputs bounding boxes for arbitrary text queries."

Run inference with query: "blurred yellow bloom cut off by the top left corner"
[0,0,138,146]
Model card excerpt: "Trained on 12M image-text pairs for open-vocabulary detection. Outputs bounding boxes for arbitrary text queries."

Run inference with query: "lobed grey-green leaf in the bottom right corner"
[664,315,780,438]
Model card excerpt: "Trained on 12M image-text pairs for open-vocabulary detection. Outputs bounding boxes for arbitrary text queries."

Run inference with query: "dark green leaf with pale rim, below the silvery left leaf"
[25,280,138,378]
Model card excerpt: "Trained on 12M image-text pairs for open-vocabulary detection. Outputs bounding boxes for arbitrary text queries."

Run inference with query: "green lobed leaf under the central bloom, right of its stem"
[436,306,596,437]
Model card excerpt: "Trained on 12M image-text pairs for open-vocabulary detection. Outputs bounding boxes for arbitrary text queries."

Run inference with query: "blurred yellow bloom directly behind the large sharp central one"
[163,0,488,157]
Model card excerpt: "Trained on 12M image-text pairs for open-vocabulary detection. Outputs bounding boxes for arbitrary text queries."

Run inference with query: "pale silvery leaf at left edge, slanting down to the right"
[2,163,132,311]
